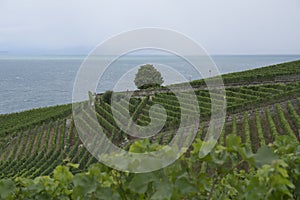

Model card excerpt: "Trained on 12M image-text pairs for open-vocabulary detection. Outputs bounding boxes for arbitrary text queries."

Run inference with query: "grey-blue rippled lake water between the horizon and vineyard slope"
[0,55,300,114]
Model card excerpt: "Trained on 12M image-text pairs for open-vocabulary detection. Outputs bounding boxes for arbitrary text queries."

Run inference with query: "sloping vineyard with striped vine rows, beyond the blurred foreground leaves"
[0,61,300,199]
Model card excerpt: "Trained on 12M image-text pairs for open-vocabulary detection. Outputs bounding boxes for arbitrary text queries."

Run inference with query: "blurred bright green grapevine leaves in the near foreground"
[0,135,300,199]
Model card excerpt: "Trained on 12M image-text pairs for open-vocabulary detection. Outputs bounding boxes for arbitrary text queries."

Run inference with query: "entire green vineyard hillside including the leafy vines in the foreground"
[0,61,300,199]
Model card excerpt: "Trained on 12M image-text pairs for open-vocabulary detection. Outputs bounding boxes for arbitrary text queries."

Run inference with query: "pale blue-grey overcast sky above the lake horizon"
[0,0,300,54]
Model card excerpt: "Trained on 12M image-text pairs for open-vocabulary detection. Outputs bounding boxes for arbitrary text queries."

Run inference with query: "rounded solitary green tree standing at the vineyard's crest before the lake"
[134,64,164,89]
